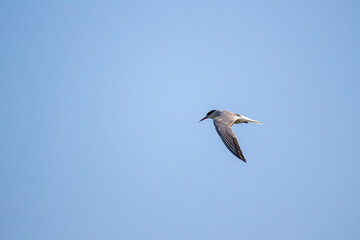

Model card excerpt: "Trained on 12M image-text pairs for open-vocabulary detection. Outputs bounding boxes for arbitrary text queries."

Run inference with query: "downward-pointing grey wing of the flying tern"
[214,119,246,162]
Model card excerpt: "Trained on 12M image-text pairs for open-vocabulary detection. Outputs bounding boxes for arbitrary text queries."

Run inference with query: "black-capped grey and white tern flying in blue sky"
[199,110,261,162]
